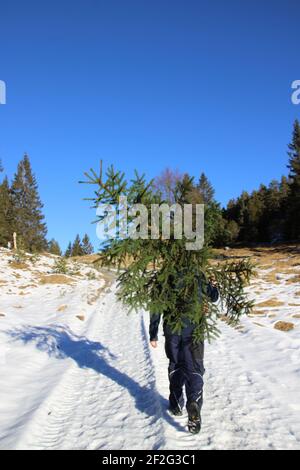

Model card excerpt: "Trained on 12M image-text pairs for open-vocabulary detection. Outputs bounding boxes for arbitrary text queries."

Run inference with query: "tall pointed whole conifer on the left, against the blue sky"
[11,154,47,252]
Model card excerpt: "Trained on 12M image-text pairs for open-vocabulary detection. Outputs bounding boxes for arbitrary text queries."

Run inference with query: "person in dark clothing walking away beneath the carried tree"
[149,270,219,434]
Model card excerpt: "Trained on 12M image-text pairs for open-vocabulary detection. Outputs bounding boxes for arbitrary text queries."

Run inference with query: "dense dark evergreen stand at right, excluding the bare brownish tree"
[222,121,300,244]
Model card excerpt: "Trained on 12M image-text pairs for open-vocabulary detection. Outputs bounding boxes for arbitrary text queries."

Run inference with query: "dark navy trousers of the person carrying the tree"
[165,329,205,409]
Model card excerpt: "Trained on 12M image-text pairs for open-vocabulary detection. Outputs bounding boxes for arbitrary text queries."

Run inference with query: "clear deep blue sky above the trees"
[0,0,300,252]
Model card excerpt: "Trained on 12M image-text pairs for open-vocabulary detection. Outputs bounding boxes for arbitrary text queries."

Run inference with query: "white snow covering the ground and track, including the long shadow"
[0,249,300,450]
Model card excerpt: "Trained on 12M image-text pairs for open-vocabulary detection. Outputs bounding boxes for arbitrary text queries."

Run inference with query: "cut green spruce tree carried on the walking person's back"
[81,164,253,342]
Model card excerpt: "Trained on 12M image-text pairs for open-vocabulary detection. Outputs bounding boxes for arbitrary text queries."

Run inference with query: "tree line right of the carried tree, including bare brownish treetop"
[154,121,300,247]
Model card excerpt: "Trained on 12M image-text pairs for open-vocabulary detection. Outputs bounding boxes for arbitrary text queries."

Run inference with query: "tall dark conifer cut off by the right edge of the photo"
[287,121,300,240]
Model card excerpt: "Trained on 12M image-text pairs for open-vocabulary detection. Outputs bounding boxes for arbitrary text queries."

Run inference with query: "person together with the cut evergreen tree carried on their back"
[85,162,253,433]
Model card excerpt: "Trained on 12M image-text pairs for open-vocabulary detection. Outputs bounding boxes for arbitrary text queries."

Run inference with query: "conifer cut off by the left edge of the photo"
[0,177,13,247]
